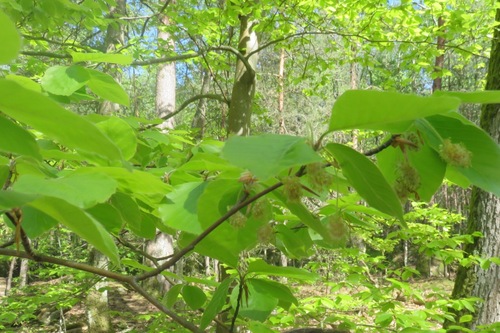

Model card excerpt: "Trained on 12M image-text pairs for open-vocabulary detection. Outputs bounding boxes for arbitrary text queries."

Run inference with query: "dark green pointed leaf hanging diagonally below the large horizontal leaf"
[326,143,404,222]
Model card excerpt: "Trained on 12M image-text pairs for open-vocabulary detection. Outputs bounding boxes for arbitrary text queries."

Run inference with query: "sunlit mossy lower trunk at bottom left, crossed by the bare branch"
[86,249,113,333]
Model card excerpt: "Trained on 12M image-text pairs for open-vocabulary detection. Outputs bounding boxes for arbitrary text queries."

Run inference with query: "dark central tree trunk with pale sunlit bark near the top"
[227,15,258,135]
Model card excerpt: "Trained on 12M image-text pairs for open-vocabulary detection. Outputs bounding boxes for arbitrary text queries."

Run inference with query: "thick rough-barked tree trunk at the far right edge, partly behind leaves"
[448,9,500,332]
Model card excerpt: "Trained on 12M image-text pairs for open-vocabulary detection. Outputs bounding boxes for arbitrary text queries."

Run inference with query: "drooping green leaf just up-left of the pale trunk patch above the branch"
[111,192,156,239]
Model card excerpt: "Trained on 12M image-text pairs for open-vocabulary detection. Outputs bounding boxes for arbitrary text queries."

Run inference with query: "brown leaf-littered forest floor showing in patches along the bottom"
[0,278,453,333]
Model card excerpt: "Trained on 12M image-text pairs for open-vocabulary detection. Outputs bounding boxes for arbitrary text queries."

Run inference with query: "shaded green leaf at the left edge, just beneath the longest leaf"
[0,115,42,160]
